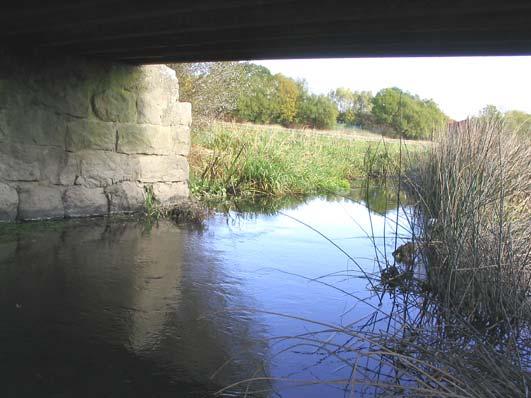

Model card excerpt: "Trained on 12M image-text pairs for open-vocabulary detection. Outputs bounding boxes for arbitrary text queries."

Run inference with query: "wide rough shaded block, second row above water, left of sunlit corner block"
[70,150,138,188]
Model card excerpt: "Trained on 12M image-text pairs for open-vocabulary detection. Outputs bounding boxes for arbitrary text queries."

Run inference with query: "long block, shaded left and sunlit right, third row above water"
[117,124,176,155]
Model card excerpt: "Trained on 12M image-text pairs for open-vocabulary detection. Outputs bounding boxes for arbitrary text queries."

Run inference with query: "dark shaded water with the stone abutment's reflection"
[0,220,265,397]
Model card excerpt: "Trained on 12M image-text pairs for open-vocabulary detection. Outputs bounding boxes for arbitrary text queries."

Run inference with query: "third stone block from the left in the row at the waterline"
[63,186,108,217]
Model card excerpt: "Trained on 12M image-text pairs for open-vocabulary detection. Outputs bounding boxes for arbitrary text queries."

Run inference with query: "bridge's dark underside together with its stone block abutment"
[0,0,531,221]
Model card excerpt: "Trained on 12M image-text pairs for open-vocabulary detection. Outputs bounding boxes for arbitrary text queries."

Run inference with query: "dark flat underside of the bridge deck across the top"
[0,0,531,63]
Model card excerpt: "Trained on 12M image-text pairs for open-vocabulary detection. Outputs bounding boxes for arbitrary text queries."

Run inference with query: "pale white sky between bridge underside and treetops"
[254,57,531,120]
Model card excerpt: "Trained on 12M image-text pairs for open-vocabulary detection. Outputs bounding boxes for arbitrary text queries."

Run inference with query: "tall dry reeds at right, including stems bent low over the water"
[213,119,531,398]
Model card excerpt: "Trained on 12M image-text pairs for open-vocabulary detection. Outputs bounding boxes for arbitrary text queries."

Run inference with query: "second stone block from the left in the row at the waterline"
[18,184,65,220]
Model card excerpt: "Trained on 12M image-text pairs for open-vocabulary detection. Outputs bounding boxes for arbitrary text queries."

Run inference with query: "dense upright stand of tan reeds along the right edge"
[374,115,531,397]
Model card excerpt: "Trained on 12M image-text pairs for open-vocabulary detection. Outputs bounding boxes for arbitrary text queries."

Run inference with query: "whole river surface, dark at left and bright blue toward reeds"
[0,186,416,398]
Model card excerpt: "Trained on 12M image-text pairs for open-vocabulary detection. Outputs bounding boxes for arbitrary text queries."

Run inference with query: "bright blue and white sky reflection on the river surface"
[206,199,414,397]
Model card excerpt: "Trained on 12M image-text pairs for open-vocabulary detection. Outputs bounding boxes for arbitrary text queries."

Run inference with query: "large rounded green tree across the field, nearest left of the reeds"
[372,87,448,139]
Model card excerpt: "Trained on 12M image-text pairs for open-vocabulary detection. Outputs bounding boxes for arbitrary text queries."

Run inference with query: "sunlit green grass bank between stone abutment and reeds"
[190,122,420,198]
